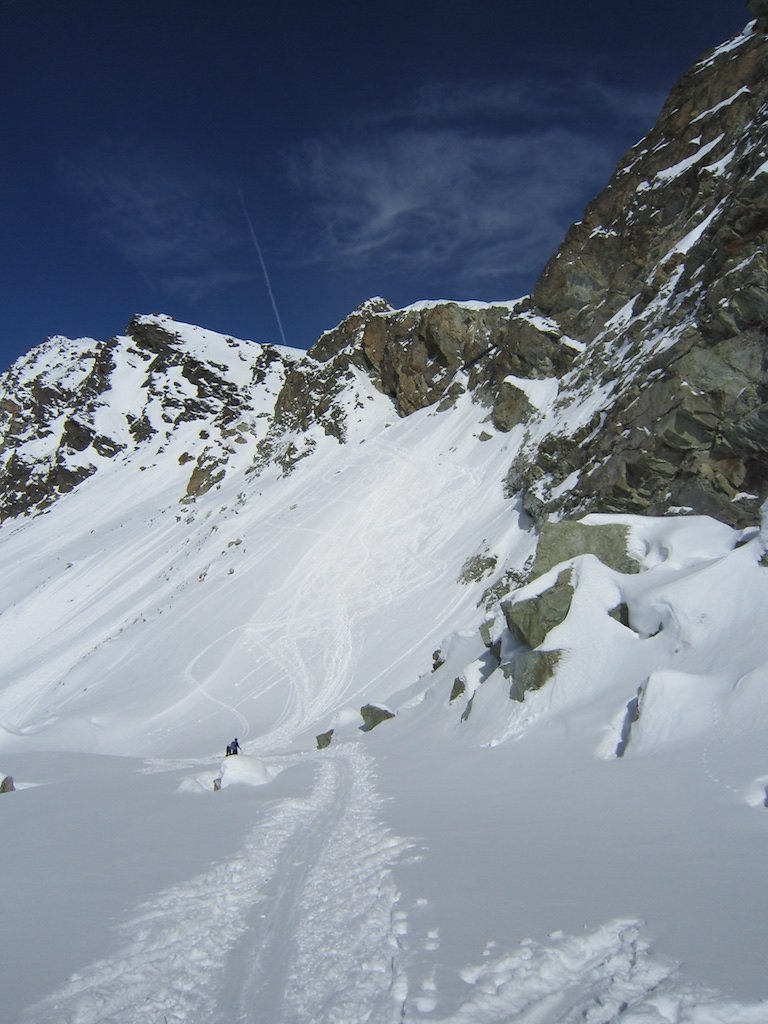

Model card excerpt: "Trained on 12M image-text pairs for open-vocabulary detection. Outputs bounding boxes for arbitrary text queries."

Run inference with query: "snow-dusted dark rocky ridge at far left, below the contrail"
[0,316,292,521]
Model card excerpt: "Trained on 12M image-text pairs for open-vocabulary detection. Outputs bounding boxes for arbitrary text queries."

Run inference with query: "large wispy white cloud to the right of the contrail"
[292,80,660,286]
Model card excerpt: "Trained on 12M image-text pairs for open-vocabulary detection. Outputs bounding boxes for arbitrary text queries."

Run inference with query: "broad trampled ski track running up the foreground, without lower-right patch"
[23,745,408,1024]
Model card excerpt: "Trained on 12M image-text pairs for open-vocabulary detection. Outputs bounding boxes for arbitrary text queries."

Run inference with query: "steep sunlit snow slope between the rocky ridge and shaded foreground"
[0,378,534,755]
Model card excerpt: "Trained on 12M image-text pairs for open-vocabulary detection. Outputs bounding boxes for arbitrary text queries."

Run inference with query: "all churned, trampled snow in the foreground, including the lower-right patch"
[19,743,768,1024]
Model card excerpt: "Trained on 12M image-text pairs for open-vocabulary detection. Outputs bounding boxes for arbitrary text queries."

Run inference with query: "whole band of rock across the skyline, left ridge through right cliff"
[0,8,768,525]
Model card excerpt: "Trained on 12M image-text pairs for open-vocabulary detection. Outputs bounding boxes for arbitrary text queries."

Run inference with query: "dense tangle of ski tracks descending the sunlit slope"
[240,439,477,751]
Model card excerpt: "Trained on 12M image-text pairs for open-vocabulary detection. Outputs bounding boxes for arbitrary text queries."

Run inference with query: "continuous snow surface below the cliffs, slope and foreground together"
[0,321,768,1024]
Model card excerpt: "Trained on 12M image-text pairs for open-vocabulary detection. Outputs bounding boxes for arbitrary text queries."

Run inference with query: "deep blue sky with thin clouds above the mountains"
[0,0,750,369]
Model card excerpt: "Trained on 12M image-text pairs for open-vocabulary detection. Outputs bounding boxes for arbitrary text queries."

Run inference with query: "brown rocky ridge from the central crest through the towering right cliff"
[264,0,768,525]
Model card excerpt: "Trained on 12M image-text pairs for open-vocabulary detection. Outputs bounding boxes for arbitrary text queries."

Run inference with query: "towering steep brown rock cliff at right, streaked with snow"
[510,12,768,525]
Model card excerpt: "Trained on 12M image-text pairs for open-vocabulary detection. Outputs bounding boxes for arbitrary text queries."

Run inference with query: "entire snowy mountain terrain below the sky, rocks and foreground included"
[0,8,768,1024]
